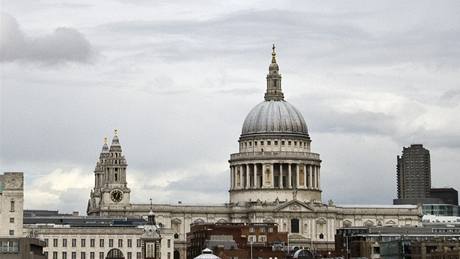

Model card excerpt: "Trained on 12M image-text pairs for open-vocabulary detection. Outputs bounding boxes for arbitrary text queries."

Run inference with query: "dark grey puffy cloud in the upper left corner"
[0,14,94,64]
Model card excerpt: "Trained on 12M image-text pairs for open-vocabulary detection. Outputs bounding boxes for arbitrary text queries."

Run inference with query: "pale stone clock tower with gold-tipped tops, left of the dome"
[87,130,131,216]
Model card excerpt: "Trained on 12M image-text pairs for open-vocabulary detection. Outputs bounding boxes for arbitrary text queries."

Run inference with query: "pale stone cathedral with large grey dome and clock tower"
[87,48,422,258]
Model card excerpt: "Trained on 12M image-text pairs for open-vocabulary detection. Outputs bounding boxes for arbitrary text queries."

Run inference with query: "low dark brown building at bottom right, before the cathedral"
[335,225,460,259]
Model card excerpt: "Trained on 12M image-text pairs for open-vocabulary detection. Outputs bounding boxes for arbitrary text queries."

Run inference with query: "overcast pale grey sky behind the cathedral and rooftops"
[0,0,460,212]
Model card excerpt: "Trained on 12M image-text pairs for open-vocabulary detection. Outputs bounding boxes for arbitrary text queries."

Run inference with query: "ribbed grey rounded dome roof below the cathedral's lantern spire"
[241,100,308,137]
